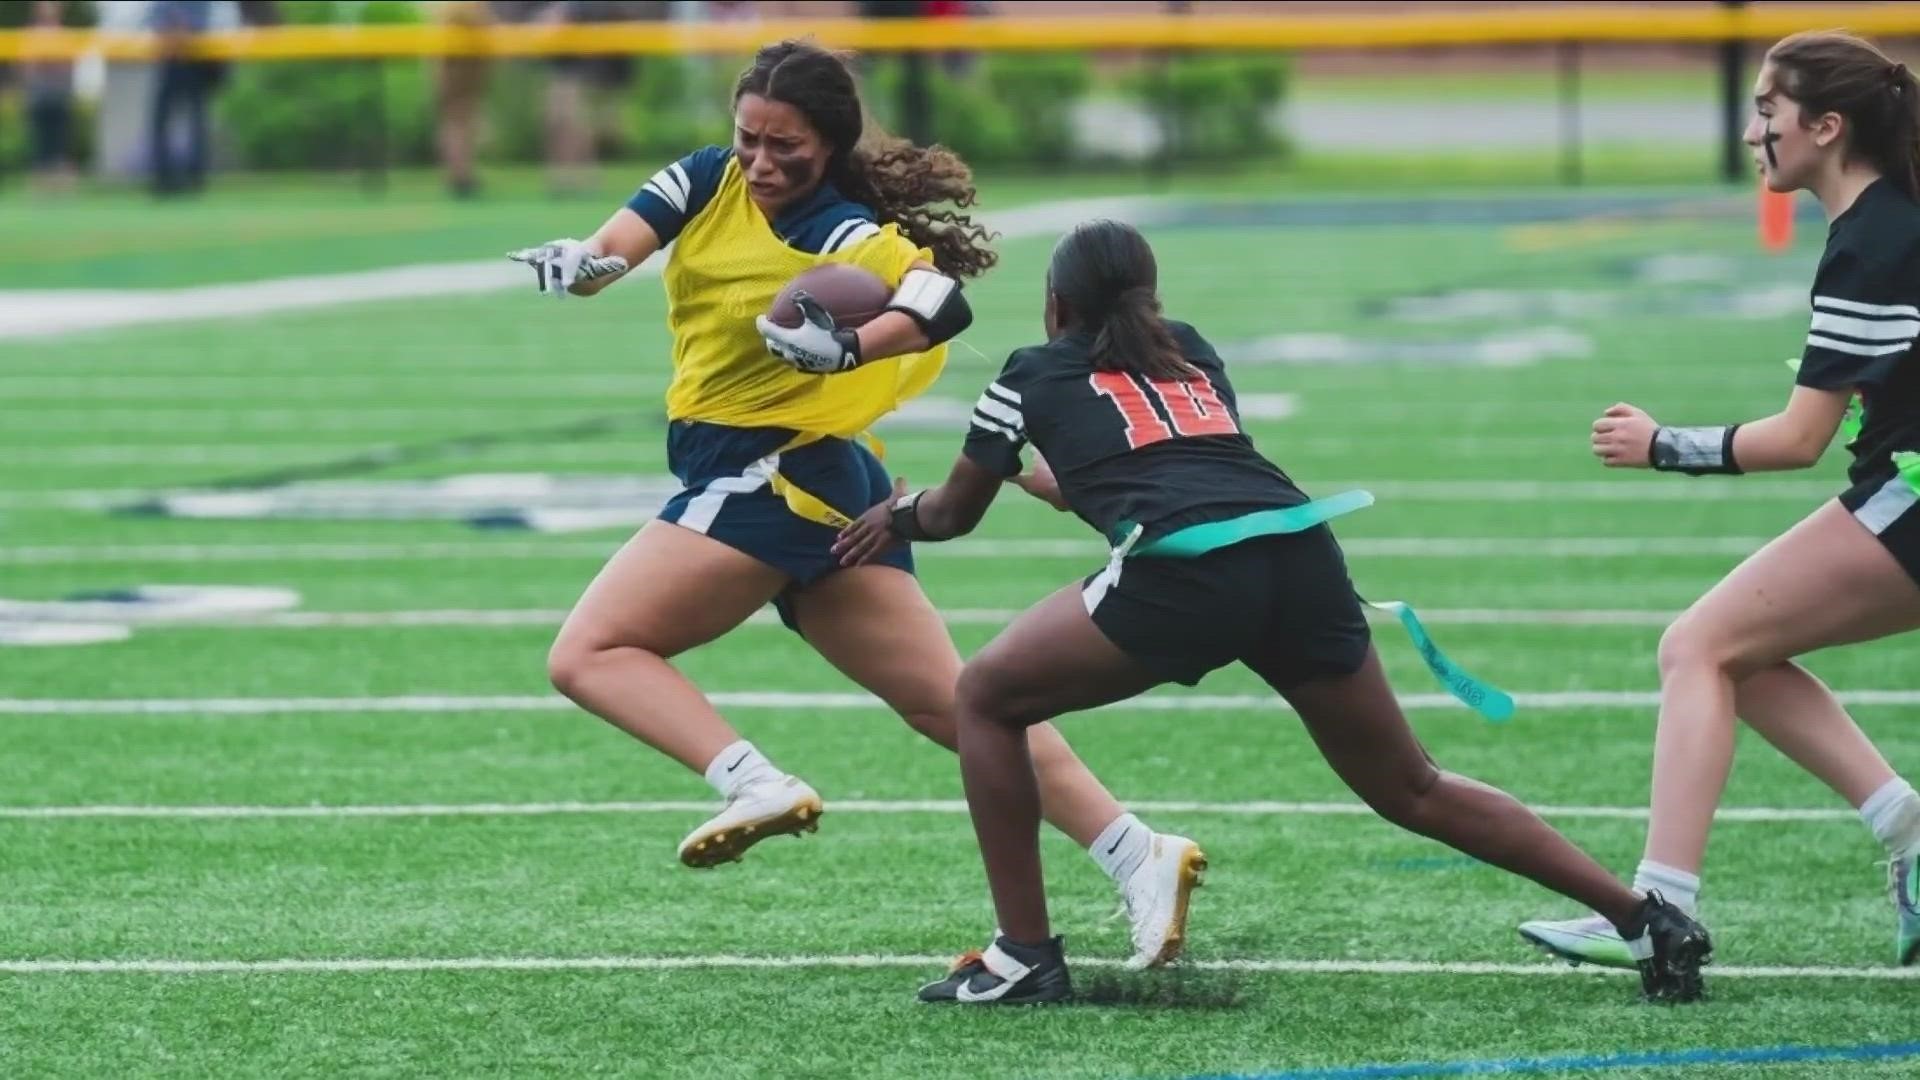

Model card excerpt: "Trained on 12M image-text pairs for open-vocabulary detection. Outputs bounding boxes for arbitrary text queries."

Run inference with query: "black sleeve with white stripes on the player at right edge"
[1799,248,1920,390]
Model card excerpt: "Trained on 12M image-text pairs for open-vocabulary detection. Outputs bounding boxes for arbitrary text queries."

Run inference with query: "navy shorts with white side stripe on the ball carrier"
[659,421,914,628]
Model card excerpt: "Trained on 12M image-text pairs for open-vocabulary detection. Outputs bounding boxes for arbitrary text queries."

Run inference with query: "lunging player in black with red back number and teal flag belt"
[839,221,1711,1003]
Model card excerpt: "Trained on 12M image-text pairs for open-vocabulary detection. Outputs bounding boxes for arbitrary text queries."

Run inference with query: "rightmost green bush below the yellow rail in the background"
[1123,56,1288,161]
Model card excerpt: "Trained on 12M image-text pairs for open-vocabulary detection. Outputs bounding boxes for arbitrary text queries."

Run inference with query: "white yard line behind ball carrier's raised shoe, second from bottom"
[0,799,1860,822]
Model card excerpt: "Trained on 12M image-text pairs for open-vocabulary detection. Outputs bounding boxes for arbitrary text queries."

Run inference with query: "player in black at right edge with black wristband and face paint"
[1521,33,1920,965]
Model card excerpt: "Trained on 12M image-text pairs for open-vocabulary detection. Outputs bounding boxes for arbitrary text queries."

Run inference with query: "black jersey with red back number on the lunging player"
[966,321,1308,540]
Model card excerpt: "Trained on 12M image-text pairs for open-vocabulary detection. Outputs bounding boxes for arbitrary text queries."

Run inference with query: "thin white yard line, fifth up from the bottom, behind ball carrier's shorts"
[0,536,1768,565]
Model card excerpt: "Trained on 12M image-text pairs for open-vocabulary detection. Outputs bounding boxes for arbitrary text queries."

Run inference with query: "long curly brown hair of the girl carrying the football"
[733,40,1000,277]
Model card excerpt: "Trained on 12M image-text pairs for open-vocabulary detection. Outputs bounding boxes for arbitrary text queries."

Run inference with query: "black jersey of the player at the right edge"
[1799,179,1920,484]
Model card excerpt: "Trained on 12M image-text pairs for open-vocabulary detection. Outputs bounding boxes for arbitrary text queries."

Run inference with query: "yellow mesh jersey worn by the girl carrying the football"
[662,160,947,444]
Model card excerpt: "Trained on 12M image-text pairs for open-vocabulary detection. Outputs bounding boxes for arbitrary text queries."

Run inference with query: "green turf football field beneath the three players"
[0,180,1920,1078]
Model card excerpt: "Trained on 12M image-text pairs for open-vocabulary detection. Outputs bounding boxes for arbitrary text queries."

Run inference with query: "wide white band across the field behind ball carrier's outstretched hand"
[0,196,1152,340]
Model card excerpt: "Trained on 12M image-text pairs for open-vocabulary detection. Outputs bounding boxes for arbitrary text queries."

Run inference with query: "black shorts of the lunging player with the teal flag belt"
[1081,525,1371,690]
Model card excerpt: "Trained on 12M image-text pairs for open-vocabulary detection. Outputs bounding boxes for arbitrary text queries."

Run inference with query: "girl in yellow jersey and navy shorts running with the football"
[513,42,1204,965]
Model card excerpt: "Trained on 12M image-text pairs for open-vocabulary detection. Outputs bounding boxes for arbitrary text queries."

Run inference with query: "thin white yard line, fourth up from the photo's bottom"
[26,601,1678,630]
